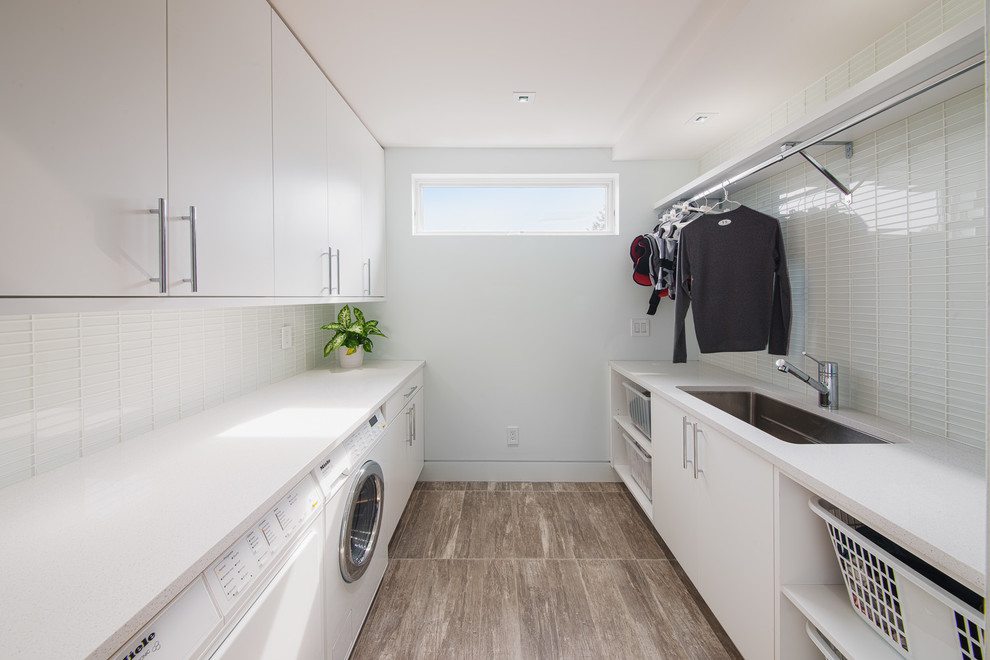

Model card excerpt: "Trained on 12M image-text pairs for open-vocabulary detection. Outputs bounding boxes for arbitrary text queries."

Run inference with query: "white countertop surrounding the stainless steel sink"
[610,362,987,593]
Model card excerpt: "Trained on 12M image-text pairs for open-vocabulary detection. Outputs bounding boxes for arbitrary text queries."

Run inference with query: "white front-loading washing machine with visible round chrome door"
[314,409,389,660]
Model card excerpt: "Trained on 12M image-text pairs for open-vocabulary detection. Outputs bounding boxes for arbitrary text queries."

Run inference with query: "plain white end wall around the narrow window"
[366,149,696,479]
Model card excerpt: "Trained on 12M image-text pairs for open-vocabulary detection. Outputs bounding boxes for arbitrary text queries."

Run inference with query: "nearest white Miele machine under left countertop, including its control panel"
[111,475,326,660]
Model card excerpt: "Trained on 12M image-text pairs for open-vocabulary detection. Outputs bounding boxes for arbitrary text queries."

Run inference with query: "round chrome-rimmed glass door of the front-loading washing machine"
[340,461,385,582]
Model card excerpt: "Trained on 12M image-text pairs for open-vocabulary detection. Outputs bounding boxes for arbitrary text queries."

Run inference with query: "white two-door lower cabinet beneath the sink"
[652,396,774,658]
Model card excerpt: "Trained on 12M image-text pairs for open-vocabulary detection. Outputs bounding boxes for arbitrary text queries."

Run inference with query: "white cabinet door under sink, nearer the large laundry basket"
[691,424,774,658]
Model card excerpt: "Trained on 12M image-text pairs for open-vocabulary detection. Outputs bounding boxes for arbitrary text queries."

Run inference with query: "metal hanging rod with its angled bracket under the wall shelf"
[668,53,986,207]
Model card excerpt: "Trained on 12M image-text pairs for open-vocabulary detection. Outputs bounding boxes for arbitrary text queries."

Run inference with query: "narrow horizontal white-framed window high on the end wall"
[412,174,619,236]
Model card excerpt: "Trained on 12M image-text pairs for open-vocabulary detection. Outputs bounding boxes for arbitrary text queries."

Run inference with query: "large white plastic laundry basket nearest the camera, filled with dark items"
[808,498,990,660]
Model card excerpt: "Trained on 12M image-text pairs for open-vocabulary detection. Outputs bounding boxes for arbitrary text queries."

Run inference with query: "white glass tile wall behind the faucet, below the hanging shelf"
[702,87,988,446]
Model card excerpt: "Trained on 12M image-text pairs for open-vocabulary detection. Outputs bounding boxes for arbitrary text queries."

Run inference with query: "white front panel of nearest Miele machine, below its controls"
[210,525,325,660]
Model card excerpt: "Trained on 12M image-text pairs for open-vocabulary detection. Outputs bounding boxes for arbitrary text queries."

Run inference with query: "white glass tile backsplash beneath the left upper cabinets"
[0,305,333,487]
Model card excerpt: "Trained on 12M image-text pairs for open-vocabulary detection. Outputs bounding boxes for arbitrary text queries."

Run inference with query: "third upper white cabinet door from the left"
[272,14,330,296]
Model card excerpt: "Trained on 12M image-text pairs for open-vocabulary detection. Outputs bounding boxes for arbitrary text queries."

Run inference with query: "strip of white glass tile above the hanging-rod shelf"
[699,0,986,172]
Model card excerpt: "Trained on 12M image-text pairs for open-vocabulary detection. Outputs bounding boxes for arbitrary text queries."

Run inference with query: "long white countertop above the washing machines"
[0,361,423,659]
